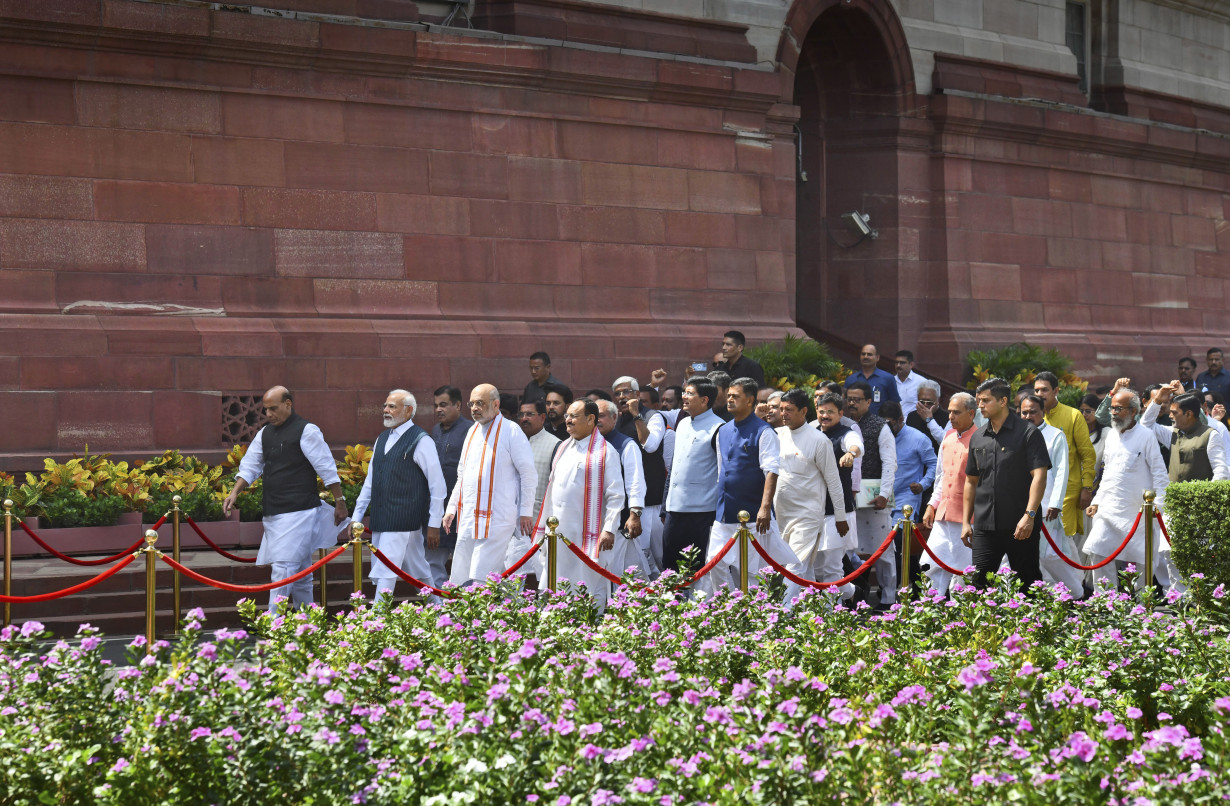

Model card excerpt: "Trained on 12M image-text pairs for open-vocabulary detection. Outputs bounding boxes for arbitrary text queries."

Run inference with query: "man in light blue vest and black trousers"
[662,375,722,573]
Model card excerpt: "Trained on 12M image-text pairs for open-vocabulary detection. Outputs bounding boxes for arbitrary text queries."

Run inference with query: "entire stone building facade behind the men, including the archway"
[0,0,1230,468]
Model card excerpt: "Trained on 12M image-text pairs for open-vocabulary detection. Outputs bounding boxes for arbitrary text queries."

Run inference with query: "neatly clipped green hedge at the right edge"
[1166,481,1230,595]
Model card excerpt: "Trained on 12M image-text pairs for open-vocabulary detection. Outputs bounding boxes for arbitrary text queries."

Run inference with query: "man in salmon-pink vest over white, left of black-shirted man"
[919,391,978,594]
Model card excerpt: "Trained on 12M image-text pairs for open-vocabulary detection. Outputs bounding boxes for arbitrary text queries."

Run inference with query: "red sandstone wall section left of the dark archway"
[0,0,793,468]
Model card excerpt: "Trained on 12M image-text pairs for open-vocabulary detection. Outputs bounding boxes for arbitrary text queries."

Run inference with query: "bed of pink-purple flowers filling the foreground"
[0,580,1230,806]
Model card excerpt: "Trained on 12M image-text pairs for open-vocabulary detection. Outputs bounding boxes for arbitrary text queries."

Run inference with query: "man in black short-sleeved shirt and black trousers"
[961,378,1050,591]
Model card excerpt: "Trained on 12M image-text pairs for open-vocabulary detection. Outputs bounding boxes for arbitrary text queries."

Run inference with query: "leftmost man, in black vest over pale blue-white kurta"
[223,386,349,610]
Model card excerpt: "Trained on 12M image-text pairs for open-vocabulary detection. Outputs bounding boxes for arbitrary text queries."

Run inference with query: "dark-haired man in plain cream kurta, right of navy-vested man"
[772,389,854,602]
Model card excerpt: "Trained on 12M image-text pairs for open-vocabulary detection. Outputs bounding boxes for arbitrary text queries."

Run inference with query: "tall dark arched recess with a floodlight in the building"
[779,0,927,354]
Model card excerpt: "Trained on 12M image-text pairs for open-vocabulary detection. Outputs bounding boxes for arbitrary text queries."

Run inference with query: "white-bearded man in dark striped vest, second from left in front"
[354,389,448,599]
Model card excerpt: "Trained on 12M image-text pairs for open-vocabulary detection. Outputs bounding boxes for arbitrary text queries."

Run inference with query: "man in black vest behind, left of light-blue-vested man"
[604,375,668,569]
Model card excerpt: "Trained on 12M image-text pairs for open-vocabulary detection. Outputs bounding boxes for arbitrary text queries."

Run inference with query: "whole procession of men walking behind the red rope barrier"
[224,345,1230,607]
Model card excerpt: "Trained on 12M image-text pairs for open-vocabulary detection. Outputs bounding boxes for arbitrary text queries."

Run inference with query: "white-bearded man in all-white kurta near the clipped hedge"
[1085,389,1167,587]
